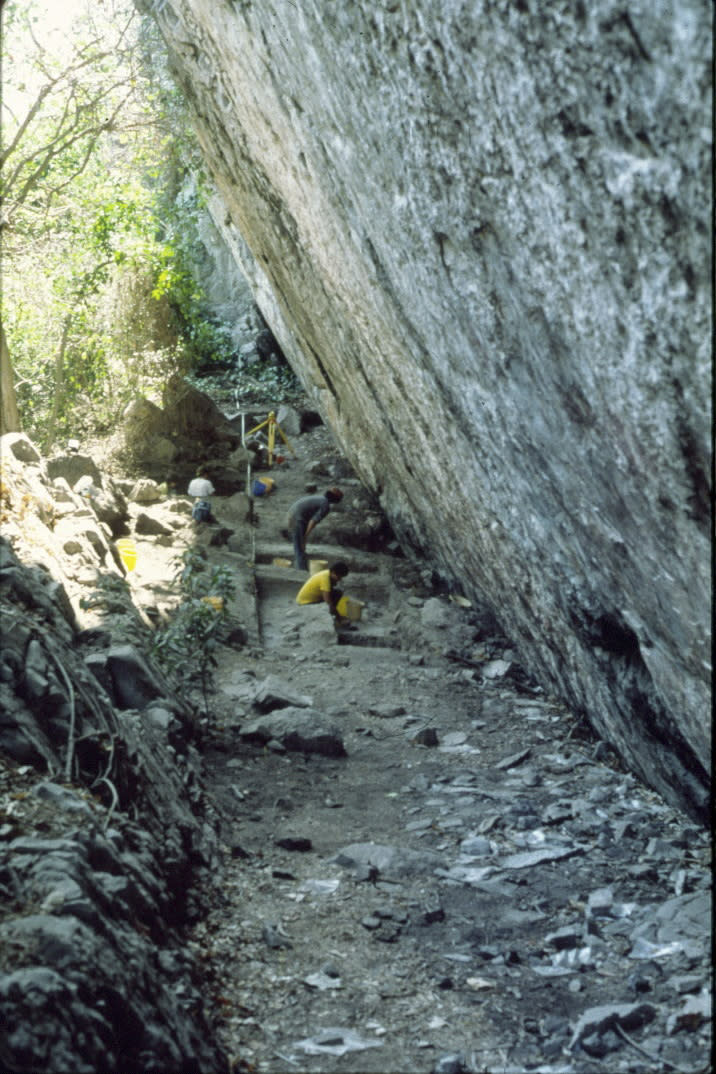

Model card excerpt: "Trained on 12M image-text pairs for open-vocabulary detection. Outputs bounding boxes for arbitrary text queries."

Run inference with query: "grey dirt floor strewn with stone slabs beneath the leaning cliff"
[124,410,711,1074]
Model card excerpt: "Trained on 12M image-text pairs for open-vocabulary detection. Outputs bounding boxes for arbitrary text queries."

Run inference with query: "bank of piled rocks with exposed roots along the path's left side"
[0,434,224,1072]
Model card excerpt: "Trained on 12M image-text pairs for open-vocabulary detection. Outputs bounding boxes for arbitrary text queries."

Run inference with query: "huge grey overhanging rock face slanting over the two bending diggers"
[144,0,711,815]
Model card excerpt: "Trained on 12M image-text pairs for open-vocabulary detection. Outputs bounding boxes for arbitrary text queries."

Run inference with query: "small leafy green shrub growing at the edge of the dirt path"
[151,548,236,714]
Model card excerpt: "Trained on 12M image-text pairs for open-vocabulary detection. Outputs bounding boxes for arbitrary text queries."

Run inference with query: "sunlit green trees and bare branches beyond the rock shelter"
[0,0,240,450]
